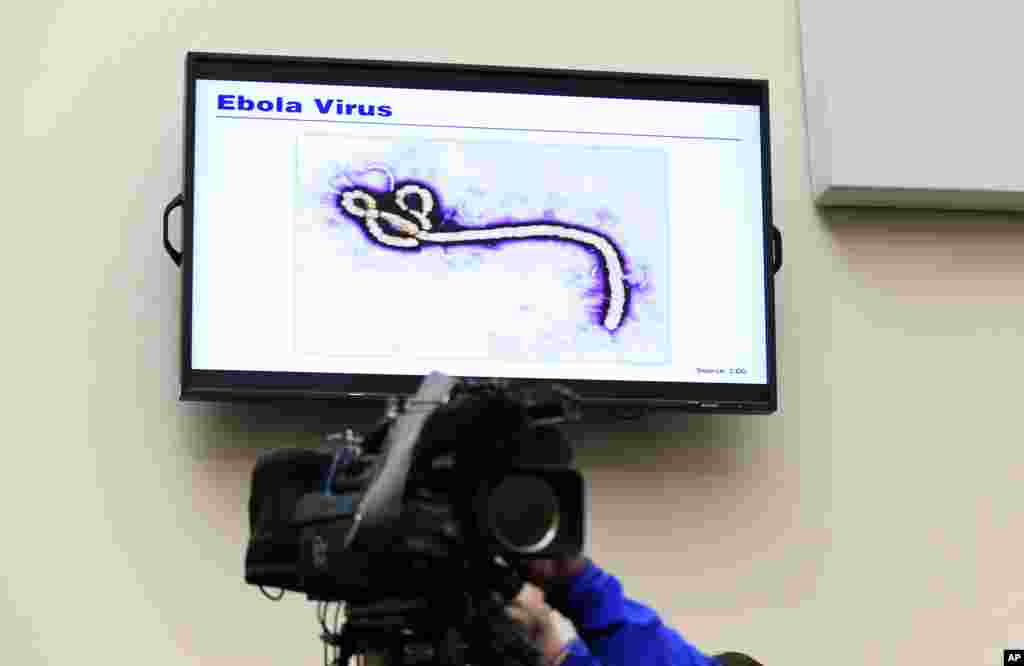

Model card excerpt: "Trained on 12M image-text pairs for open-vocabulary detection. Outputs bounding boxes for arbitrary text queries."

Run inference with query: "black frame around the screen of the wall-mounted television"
[179,52,778,414]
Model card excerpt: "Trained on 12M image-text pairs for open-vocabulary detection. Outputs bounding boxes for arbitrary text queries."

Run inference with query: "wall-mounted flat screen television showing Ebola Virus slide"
[180,53,781,413]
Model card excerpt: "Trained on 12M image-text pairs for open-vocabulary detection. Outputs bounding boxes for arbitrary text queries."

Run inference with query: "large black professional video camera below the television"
[245,373,585,666]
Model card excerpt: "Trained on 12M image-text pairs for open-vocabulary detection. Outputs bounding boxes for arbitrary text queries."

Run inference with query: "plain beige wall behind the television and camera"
[0,0,1024,666]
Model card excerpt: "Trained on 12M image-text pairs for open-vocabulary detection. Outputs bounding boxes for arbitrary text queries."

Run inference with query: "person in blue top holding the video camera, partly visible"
[507,557,759,666]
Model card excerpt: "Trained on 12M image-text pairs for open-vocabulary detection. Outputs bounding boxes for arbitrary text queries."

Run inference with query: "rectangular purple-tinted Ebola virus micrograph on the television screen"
[291,132,673,362]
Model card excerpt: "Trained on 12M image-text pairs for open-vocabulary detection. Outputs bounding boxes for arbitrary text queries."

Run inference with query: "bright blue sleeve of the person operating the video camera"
[551,561,716,666]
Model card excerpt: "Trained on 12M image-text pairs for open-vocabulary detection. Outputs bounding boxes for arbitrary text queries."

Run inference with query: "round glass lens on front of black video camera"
[487,474,559,553]
